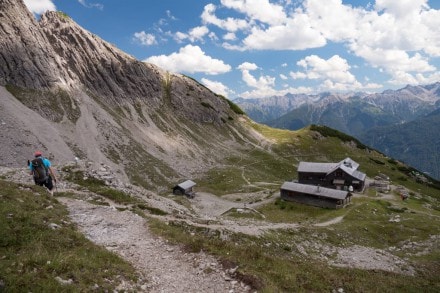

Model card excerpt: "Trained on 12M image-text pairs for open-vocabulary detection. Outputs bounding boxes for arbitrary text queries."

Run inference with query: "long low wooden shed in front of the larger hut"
[280,182,352,209]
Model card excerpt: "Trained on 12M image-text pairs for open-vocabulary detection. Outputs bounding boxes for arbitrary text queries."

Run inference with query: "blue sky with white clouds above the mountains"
[24,0,440,100]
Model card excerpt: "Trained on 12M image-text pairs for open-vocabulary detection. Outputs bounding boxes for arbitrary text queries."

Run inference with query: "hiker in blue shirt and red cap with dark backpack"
[28,151,57,195]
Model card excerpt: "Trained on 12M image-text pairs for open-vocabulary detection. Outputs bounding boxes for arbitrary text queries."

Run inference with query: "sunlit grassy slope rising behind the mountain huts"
[199,120,440,196]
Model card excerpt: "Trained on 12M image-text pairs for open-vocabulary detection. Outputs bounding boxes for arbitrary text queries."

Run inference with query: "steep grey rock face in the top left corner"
[0,0,63,88]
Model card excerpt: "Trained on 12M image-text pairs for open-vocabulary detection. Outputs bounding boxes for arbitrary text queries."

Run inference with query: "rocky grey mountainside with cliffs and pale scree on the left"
[0,0,258,187]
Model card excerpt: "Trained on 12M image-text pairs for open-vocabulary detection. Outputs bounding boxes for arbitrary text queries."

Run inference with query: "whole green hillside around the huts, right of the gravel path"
[148,122,440,292]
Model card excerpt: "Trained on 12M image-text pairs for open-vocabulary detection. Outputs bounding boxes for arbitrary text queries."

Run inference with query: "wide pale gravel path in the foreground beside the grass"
[59,198,250,293]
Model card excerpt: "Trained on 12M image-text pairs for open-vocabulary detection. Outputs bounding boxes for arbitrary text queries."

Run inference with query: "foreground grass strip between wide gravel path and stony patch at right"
[151,212,440,292]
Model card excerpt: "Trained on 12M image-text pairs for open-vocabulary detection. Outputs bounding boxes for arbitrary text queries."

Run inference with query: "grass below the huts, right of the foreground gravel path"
[145,185,440,292]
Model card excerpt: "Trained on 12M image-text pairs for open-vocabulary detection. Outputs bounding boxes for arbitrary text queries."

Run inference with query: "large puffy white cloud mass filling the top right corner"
[304,0,440,82]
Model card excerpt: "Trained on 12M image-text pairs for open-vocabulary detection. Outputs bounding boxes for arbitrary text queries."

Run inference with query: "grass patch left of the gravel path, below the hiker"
[0,181,137,292]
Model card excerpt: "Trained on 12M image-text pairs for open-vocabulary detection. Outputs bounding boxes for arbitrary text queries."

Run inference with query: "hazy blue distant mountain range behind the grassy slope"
[235,82,440,179]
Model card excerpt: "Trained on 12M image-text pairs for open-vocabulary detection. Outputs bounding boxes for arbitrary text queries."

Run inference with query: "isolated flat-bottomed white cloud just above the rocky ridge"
[144,45,231,75]
